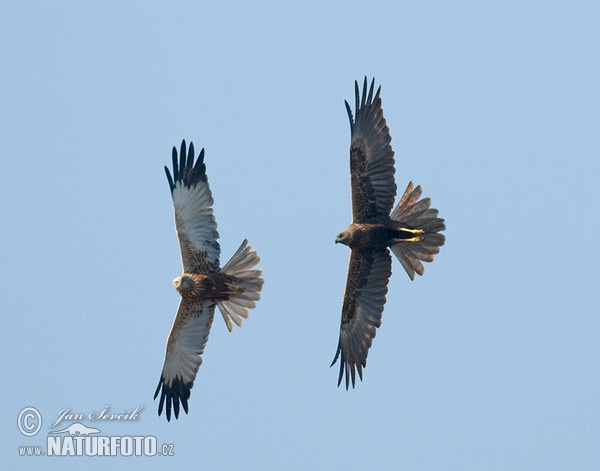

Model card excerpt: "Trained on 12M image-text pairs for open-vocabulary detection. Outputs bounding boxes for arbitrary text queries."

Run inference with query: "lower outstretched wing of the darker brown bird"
[331,248,392,389]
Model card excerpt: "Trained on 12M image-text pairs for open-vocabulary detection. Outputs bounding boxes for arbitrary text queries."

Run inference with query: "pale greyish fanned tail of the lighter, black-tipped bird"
[217,240,264,332]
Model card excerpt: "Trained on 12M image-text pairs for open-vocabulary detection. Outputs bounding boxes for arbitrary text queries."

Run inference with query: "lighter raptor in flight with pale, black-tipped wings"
[154,140,263,421]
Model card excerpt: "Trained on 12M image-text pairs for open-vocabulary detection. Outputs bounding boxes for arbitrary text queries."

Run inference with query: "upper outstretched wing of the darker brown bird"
[345,77,396,223]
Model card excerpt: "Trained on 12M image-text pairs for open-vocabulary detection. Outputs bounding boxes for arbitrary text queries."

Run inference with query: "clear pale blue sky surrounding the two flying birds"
[0,0,600,470]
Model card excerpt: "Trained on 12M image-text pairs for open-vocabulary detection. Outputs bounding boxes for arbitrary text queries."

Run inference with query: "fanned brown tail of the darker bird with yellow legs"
[390,182,446,280]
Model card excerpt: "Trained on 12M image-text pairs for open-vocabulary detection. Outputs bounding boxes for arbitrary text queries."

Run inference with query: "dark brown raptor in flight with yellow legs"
[331,77,446,389]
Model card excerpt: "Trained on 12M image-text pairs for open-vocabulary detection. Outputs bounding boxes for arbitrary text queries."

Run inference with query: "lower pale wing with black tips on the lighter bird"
[154,299,215,421]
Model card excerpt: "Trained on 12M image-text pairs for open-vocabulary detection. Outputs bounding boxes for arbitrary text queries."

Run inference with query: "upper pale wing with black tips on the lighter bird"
[165,140,221,273]
